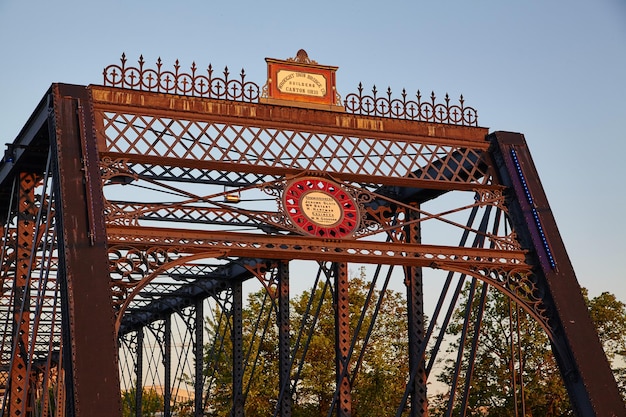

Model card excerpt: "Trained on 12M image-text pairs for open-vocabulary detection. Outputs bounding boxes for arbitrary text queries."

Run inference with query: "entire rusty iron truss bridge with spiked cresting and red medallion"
[0,51,626,417]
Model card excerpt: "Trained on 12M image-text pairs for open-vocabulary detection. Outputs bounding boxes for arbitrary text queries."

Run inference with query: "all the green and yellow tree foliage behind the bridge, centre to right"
[199,268,626,417]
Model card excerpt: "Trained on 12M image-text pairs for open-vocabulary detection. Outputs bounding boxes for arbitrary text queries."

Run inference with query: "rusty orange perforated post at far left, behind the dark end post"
[9,173,36,416]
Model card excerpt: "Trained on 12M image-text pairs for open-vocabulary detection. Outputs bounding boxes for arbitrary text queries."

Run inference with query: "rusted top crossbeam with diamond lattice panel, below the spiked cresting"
[92,87,493,190]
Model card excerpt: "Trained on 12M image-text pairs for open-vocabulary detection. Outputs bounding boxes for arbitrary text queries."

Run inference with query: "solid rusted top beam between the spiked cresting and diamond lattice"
[89,85,488,145]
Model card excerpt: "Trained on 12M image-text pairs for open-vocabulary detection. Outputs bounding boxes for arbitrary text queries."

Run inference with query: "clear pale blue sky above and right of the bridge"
[0,0,626,301]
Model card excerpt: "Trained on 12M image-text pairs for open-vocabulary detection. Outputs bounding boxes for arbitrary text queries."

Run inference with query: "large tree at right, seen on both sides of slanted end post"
[432,284,626,416]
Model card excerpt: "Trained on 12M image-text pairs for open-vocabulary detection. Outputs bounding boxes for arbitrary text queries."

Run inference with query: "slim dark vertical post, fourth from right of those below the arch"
[232,281,244,417]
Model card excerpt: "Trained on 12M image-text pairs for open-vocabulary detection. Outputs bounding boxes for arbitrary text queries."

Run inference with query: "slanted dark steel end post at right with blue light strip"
[489,132,626,417]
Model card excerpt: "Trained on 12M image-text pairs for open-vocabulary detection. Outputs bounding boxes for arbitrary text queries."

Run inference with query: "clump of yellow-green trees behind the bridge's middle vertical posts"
[205,277,408,417]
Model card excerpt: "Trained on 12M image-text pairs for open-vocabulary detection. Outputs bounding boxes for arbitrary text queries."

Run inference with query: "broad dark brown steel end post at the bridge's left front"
[49,84,122,417]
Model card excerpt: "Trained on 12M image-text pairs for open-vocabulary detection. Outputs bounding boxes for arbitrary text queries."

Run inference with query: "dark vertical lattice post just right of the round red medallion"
[404,210,428,417]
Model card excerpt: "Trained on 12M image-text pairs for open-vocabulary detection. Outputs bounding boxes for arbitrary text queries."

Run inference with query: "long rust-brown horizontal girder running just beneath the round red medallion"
[107,226,528,272]
